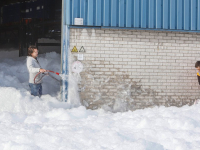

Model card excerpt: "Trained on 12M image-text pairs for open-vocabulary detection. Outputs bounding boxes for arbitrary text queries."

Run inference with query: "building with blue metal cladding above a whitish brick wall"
[62,0,200,111]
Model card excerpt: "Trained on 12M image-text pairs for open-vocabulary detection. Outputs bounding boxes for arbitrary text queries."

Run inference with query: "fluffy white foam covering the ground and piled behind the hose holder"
[0,51,200,150]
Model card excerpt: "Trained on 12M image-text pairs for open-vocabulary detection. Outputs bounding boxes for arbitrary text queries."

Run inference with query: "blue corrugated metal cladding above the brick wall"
[65,0,200,31]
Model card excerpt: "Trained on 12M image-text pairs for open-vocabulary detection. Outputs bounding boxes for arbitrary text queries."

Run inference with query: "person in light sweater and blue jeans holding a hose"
[27,46,46,97]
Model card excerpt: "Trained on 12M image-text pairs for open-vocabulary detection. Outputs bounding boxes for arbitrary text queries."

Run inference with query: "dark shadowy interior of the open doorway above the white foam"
[0,0,62,56]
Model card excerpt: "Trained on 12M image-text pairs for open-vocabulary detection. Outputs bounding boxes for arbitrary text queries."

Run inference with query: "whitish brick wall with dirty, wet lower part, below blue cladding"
[70,28,200,112]
